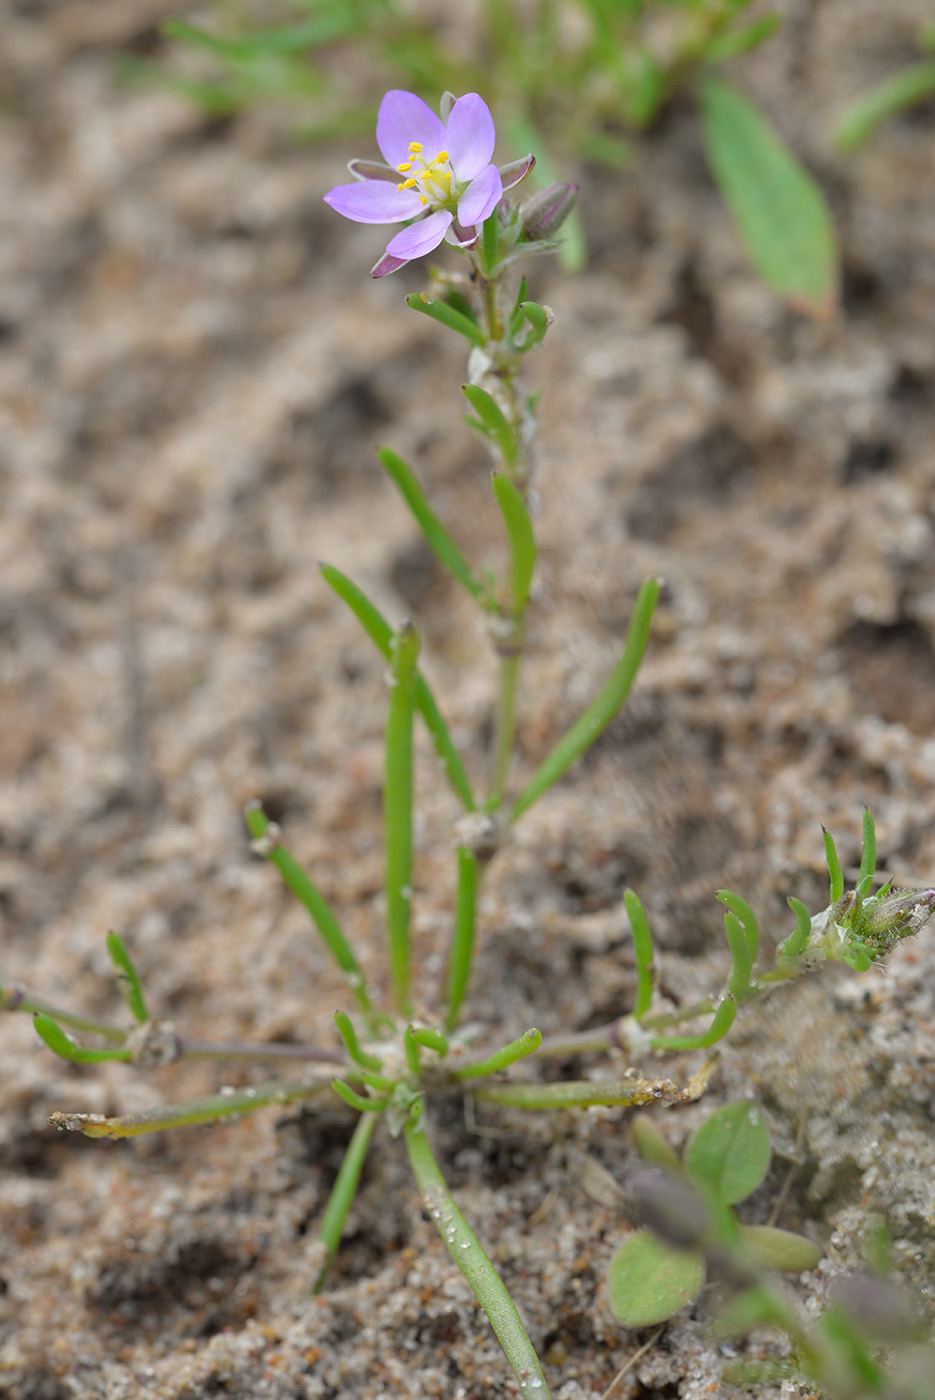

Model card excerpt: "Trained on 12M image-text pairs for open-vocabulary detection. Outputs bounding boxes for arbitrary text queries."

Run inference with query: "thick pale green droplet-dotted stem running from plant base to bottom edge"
[403,1120,551,1400]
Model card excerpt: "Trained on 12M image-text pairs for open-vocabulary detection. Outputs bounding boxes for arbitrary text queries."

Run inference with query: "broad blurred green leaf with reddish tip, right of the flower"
[698,76,838,321]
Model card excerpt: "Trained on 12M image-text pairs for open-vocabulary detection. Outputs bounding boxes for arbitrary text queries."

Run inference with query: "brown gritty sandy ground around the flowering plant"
[0,0,935,1400]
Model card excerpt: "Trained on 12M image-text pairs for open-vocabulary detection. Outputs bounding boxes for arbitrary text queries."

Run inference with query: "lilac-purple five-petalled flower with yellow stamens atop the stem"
[325,90,532,277]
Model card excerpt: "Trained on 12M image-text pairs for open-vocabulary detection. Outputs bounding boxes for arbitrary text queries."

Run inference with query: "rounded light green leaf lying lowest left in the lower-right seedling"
[607,1229,704,1327]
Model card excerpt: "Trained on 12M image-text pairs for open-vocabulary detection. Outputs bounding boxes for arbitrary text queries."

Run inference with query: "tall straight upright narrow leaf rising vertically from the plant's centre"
[384,622,419,1016]
